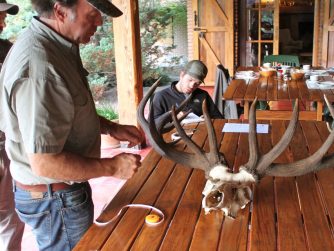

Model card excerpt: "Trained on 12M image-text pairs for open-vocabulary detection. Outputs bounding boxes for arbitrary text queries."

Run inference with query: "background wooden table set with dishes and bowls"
[224,67,334,121]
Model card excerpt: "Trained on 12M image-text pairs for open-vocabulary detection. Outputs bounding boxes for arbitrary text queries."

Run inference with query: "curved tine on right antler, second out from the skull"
[256,99,299,174]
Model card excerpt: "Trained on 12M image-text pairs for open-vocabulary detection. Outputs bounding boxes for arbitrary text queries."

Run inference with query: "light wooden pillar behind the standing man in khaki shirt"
[112,0,143,126]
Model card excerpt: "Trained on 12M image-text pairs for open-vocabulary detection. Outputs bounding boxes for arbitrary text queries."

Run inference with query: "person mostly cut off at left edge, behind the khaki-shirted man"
[0,0,24,250]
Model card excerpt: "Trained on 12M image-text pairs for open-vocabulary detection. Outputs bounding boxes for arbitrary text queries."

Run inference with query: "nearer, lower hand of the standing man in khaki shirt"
[101,153,141,179]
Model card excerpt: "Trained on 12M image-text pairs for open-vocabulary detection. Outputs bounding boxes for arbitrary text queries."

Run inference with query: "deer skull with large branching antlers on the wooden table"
[138,80,334,218]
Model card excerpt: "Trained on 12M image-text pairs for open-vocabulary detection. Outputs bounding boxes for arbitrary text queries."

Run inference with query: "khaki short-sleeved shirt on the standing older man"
[0,18,100,184]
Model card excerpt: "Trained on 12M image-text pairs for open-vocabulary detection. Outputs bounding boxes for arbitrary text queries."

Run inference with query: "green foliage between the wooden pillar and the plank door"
[139,0,187,85]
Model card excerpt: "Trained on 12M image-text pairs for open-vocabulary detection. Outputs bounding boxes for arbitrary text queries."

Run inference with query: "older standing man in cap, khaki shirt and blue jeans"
[0,0,143,251]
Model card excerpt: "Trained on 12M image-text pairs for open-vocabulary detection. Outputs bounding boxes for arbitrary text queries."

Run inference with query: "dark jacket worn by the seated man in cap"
[153,82,223,124]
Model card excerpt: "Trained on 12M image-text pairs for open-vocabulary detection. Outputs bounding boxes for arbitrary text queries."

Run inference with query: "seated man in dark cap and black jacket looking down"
[153,60,223,125]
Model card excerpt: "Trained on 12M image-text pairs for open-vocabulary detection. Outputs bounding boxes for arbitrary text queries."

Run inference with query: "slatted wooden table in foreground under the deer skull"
[75,120,334,251]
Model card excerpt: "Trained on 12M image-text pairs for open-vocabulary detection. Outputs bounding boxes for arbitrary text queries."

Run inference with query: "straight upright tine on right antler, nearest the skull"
[244,97,259,172]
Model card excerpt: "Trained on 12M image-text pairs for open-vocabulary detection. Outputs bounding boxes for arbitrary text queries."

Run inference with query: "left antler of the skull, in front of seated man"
[137,80,223,172]
